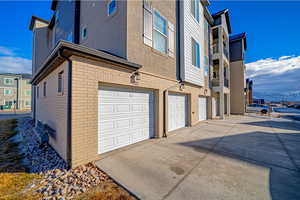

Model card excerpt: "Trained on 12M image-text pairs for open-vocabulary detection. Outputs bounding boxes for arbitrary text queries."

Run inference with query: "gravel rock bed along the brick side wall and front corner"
[18,118,118,200]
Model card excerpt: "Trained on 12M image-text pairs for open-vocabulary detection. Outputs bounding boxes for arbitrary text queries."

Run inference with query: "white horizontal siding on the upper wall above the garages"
[181,0,208,86]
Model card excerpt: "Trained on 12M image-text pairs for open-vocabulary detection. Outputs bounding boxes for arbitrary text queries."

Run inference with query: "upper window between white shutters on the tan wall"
[153,11,168,53]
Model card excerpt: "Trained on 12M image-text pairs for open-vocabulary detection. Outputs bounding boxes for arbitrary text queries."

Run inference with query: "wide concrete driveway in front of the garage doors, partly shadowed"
[96,116,300,200]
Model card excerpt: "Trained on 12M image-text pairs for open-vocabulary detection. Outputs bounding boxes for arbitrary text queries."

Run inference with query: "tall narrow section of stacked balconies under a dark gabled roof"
[211,9,231,119]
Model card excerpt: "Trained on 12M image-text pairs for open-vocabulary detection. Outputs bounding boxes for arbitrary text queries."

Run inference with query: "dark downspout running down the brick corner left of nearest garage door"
[58,50,72,168]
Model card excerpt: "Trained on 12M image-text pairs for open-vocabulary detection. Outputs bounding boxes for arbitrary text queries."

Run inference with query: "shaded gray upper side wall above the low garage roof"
[80,0,126,58]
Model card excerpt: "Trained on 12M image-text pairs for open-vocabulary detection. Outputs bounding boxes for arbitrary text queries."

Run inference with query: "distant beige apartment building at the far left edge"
[0,73,31,110]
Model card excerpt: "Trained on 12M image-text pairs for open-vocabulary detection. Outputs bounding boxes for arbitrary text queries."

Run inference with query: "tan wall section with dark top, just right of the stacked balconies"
[229,33,247,115]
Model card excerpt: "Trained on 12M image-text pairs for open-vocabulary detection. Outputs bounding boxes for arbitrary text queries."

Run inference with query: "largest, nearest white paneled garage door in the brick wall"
[98,88,154,154]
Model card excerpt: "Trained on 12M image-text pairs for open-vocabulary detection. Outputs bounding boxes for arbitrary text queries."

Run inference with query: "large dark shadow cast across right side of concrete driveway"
[179,131,300,200]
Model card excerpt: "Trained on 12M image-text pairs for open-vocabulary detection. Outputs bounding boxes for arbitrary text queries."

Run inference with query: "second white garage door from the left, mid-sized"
[168,94,187,131]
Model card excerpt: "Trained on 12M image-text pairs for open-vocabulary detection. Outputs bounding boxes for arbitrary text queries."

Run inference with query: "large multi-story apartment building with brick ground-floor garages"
[30,0,246,167]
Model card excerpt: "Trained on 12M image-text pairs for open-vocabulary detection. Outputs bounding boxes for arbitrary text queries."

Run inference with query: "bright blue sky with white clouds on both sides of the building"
[0,0,300,99]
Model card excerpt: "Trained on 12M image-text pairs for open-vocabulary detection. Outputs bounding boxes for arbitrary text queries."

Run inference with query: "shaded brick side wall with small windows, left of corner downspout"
[36,61,68,161]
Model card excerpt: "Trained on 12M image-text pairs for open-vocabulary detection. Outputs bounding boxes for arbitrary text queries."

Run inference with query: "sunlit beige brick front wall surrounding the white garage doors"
[72,57,210,167]
